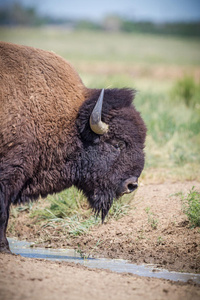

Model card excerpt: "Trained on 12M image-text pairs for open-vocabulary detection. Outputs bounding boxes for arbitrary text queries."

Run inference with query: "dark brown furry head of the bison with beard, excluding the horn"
[75,89,146,220]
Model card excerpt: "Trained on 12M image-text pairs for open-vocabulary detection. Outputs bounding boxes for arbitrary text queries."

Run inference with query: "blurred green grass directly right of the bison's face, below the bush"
[136,93,200,173]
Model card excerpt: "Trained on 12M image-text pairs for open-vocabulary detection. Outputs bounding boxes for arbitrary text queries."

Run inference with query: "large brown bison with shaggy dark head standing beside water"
[0,42,146,252]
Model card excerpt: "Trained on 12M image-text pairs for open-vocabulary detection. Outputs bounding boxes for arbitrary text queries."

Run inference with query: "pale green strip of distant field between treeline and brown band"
[0,28,200,66]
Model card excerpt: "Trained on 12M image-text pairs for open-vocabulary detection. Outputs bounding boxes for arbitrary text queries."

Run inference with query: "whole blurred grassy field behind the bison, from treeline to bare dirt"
[0,28,200,230]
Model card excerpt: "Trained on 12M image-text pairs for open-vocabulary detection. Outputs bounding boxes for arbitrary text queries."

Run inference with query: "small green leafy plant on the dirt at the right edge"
[181,186,200,227]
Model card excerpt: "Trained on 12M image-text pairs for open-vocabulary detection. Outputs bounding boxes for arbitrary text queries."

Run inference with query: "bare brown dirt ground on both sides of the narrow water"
[0,181,200,300]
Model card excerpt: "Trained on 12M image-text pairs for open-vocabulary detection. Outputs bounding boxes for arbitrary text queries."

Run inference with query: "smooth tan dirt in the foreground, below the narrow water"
[0,254,200,300]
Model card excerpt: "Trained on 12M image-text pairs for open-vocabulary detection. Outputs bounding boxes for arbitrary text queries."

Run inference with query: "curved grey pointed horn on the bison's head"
[90,89,108,134]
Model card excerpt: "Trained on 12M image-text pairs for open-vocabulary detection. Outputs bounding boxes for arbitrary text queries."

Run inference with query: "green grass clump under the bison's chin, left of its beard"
[30,187,100,236]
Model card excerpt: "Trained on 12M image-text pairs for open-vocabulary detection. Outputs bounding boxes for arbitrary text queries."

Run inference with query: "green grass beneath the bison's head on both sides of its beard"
[27,187,133,236]
